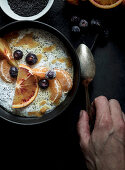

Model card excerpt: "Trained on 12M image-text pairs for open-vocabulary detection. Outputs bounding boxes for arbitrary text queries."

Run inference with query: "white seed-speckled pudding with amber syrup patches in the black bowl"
[0,28,74,117]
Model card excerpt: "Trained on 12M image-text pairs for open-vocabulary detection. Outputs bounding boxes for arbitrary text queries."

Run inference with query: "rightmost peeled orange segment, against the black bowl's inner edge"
[54,69,73,93]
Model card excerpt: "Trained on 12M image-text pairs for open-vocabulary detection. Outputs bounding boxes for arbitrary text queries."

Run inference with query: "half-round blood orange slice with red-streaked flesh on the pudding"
[12,64,38,108]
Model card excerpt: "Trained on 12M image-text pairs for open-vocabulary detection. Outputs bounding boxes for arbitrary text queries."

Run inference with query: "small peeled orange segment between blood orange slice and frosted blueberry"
[32,67,49,79]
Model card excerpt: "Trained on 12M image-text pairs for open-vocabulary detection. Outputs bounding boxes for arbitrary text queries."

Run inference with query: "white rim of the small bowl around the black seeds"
[0,0,54,21]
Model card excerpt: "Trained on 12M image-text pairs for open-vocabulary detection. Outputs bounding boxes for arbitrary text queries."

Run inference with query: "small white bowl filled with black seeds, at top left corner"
[0,0,54,20]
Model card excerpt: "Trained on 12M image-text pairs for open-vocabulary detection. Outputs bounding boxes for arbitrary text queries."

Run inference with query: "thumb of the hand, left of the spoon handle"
[77,110,90,149]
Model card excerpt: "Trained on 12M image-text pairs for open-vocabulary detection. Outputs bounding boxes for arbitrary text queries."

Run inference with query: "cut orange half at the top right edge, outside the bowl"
[89,0,123,9]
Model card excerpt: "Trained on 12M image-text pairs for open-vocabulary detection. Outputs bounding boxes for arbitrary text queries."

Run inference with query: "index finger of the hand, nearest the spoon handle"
[94,96,112,127]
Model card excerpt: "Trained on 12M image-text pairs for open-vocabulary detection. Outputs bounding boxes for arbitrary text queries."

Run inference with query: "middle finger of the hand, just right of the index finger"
[109,99,124,129]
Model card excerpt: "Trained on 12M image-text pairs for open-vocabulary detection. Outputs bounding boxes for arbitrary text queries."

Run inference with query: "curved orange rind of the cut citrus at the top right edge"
[89,0,123,9]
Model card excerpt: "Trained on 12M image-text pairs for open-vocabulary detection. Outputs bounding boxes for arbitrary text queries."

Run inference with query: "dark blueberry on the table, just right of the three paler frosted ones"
[91,19,103,32]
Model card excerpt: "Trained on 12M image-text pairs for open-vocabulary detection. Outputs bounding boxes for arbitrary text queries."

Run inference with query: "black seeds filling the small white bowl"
[8,0,49,17]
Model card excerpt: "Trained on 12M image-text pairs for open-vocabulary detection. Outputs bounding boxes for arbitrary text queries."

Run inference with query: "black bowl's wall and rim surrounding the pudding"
[0,21,80,125]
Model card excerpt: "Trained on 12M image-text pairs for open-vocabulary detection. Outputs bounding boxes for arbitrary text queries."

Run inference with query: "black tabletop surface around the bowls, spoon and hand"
[0,0,125,170]
